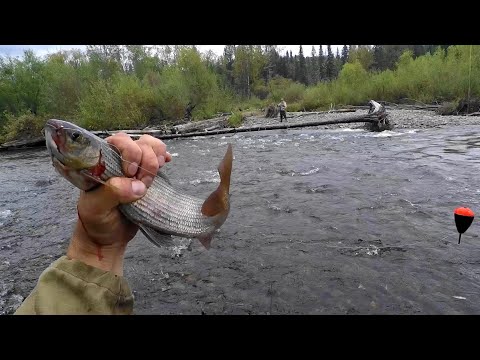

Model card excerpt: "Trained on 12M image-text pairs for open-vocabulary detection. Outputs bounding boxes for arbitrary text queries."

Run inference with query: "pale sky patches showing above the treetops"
[0,45,343,57]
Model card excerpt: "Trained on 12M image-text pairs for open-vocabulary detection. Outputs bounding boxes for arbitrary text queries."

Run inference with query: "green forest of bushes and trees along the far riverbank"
[0,45,480,143]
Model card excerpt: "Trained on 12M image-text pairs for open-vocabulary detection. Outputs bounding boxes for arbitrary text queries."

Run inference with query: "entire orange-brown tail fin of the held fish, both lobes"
[198,144,233,249]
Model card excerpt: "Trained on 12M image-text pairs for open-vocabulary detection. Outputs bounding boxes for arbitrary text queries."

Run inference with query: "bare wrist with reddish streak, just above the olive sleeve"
[67,221,126,276]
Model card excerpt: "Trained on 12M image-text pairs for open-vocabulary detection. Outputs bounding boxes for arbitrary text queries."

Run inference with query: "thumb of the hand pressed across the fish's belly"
[78,177,147,221]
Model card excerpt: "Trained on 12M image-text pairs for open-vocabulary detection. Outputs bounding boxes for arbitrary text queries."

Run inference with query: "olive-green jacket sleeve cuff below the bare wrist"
[15,256,133,315]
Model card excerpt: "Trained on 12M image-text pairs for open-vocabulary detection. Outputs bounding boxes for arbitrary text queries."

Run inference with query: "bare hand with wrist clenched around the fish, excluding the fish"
[67,133,172,275]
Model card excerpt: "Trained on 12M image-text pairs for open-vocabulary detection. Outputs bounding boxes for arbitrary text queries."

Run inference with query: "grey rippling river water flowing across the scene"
[0,125,480,314]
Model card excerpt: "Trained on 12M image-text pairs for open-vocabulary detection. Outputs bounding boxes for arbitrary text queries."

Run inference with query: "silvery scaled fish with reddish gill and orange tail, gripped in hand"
[44,119,233,249]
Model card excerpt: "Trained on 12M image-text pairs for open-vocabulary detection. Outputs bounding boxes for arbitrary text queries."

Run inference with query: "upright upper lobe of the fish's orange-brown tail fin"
[202,144,233,216]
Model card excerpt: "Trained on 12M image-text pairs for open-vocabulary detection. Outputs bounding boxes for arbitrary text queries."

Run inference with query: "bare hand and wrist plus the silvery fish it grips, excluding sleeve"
[44,119,233,273]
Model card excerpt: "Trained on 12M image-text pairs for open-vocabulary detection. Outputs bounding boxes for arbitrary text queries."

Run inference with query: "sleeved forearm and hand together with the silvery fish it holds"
[16,119,233,314]
